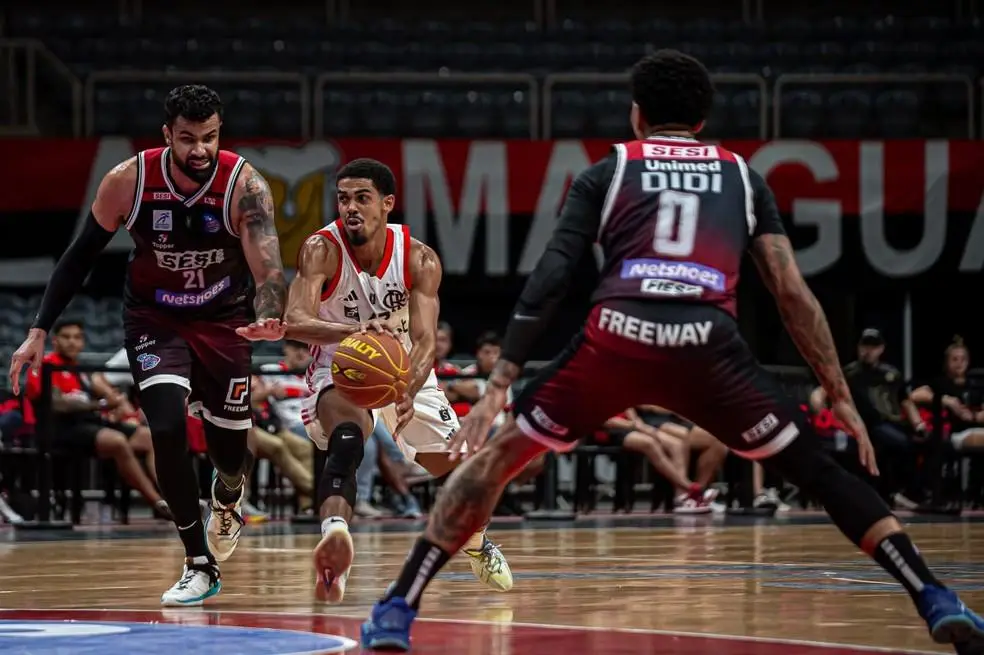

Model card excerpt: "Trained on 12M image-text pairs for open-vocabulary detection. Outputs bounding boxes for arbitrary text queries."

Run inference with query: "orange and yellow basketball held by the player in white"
[331,332,410,409]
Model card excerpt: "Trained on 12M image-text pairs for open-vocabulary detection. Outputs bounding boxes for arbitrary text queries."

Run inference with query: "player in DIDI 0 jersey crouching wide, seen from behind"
[362,50,984,653]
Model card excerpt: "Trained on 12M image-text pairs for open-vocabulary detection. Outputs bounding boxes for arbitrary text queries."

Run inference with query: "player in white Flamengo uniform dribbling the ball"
[270,159,513,603]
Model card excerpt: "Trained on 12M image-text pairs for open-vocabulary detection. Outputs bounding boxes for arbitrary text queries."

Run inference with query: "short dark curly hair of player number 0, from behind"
[631,50,714,128]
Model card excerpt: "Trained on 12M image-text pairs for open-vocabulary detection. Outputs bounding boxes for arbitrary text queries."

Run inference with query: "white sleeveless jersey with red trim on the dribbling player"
[308,221,412,390]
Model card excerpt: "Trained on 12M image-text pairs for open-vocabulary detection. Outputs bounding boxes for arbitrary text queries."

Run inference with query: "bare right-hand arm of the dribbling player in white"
[407,239,442,398]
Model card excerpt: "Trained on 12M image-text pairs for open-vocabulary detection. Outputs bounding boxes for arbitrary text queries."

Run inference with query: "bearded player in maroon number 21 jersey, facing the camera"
[10,85,287,606]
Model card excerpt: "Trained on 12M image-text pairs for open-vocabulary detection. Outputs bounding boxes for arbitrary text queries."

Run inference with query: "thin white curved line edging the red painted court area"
[25,607,940,655]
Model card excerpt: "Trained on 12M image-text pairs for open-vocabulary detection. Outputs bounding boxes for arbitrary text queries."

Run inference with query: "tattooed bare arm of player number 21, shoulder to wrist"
[232,164,287,320]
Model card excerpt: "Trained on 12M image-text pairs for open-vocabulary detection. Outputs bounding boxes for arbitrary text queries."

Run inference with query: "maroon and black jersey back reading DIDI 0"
[593,138,756,316]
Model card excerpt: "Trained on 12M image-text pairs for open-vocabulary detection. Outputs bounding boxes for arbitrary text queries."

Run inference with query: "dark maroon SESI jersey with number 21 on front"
[125,148,251,317]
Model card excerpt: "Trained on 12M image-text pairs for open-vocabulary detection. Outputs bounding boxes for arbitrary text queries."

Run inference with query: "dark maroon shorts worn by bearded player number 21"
[123,307,253,430]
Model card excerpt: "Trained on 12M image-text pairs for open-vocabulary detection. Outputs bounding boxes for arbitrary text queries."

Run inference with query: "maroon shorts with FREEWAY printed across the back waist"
[513,299,803,459]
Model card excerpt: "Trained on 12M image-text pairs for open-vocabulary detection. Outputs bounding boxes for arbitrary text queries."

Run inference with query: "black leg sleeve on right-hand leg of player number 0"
[765,428,892,547]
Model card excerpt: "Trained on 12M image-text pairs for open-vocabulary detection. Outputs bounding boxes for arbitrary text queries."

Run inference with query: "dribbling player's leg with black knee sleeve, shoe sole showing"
[313,390,372,604]
